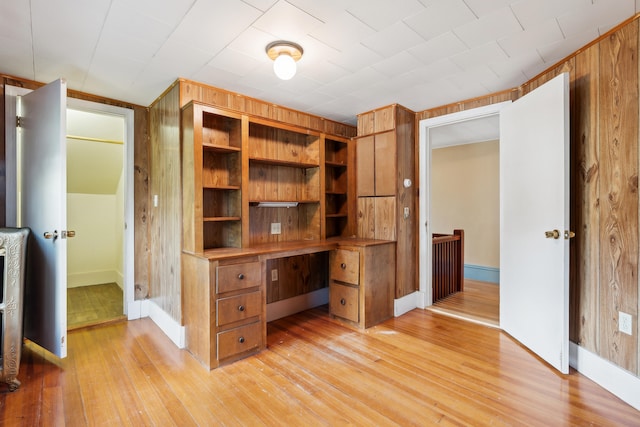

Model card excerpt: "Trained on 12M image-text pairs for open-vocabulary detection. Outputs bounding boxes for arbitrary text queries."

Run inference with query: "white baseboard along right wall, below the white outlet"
[569,342,640,411]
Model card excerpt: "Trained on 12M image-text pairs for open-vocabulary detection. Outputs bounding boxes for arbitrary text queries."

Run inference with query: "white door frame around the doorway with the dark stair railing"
[416,101,511,308]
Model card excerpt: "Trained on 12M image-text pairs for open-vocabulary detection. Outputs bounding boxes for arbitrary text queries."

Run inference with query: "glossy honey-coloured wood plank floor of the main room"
[0,307,640,426]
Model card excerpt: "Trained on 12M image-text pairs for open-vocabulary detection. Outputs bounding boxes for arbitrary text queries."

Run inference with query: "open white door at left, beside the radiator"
[18,80,67,357]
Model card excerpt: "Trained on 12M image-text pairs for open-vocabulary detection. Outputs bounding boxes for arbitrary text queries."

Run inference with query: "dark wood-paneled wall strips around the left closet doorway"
[0,75,149,300]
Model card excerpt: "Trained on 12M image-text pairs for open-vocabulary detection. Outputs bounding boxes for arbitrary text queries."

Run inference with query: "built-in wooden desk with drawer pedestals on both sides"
[182,238,395,368]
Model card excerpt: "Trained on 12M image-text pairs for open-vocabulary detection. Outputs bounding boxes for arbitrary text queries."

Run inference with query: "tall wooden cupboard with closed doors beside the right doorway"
[356,105,419,298]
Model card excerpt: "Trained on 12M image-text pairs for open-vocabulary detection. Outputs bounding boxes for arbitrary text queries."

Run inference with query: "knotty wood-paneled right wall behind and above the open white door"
[416,18,640,375]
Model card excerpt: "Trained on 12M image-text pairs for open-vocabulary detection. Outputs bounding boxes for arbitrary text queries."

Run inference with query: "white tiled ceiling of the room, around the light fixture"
[0,0,640,123]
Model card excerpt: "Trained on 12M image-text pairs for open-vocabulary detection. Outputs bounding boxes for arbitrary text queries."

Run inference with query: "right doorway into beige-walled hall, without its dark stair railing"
[420,102,510,327]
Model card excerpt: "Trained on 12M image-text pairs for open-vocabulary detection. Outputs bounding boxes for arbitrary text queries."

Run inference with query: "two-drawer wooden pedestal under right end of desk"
[329,240,395,328]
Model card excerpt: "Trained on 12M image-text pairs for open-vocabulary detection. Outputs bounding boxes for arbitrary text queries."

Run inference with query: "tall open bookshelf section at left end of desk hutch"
[182,103,242,252]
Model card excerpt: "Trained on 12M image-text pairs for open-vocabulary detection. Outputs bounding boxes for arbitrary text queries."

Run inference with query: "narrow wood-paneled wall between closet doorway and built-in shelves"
[149,85,182,323]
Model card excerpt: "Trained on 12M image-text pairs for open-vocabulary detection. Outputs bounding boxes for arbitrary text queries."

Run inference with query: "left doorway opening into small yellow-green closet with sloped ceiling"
[67,108,125,330]
